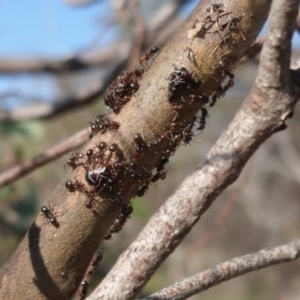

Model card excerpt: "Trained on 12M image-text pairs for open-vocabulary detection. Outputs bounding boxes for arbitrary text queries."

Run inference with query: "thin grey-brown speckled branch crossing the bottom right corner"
[144,240,300,300]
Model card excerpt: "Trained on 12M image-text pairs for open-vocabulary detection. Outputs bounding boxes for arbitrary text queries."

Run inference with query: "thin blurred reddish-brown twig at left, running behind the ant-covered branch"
[0,128,89,188]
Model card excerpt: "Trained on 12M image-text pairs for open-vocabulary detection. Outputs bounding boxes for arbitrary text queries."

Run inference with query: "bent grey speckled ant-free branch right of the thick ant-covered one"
[88,0,299,300]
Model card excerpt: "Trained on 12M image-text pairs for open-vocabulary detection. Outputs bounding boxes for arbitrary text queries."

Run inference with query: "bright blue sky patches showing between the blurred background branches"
[0,0,299,109]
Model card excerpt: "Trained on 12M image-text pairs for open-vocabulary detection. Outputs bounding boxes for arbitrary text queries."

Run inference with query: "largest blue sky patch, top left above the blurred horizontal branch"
[0,0,116,57]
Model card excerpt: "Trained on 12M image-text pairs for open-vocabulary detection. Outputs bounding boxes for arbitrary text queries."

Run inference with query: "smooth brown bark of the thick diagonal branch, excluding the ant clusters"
[0,0,270,299]
